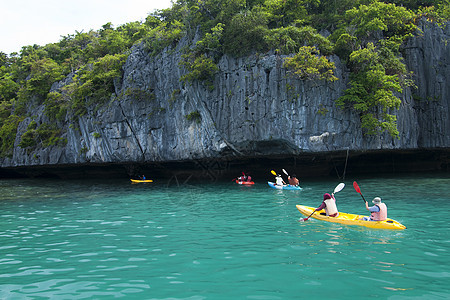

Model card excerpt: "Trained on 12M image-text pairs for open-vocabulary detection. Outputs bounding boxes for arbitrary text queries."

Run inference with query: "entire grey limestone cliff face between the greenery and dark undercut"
[1,23,450,178]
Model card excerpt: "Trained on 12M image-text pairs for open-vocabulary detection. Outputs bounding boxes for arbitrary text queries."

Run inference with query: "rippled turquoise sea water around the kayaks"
[0,173,450,299]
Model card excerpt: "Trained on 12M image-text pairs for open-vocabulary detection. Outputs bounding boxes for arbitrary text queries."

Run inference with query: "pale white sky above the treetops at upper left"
[0,0,172,54]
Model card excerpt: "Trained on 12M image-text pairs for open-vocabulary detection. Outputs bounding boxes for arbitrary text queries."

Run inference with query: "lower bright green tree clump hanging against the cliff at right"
[337,43,409,137]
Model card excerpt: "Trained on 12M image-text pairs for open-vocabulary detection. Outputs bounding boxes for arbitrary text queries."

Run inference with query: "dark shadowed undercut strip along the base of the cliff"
[0,149,450,185]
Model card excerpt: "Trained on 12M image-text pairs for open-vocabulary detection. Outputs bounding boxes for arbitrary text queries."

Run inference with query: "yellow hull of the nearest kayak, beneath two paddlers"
[296,205,406,230]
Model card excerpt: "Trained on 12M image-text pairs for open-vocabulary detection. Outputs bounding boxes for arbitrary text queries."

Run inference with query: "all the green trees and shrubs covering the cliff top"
[0,0,450,157]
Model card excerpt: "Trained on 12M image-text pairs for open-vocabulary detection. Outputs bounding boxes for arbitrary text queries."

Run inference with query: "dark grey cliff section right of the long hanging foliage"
[405,23,450,148]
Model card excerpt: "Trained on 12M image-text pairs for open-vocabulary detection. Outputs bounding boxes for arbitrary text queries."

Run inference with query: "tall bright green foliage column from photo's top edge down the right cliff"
[337,2,416,137]
